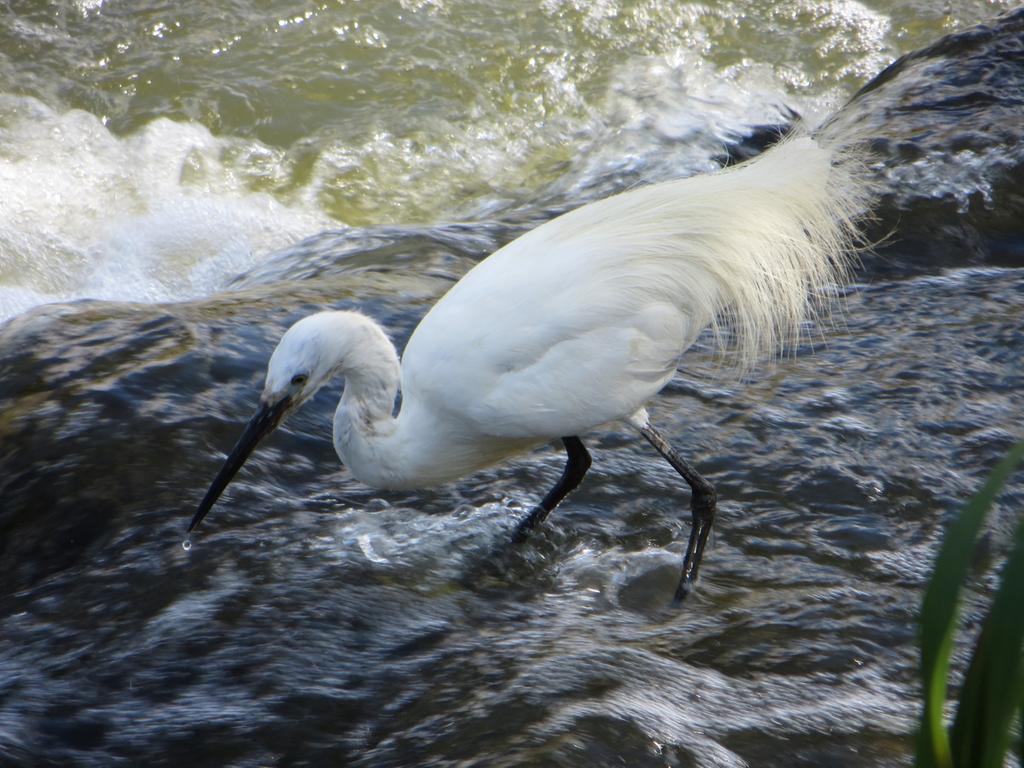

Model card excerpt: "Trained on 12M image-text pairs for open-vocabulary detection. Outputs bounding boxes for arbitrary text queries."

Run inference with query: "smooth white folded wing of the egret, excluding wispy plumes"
[402,230,708,438]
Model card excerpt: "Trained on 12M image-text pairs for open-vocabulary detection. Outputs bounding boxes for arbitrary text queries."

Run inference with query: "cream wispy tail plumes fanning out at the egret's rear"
[552,136,869,370]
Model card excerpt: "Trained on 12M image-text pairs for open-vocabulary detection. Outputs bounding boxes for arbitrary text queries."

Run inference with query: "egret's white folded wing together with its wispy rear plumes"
[402,138,865,437]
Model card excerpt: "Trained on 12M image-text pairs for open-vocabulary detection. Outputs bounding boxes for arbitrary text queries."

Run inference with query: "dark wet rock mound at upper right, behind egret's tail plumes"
[824,9,1024,273]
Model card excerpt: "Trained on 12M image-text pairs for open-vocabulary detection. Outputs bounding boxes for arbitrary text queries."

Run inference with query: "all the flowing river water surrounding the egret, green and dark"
[0,0,1024,768]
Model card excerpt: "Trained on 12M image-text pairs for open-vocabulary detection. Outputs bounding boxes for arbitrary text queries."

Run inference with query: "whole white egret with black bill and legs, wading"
[188,137,866,599]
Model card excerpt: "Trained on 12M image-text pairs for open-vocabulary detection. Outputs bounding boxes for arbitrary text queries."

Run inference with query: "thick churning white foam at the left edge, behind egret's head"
[0,96,329,321]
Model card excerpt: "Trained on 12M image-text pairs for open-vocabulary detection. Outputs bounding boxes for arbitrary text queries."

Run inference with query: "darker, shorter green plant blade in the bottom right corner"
[950,493,1024,768]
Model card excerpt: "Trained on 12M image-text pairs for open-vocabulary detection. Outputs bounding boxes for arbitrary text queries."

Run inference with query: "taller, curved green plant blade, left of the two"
[916,441,1024,768]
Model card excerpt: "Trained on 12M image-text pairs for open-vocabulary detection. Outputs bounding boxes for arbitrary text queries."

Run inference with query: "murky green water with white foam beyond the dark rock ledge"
[0,0,1001,317]
